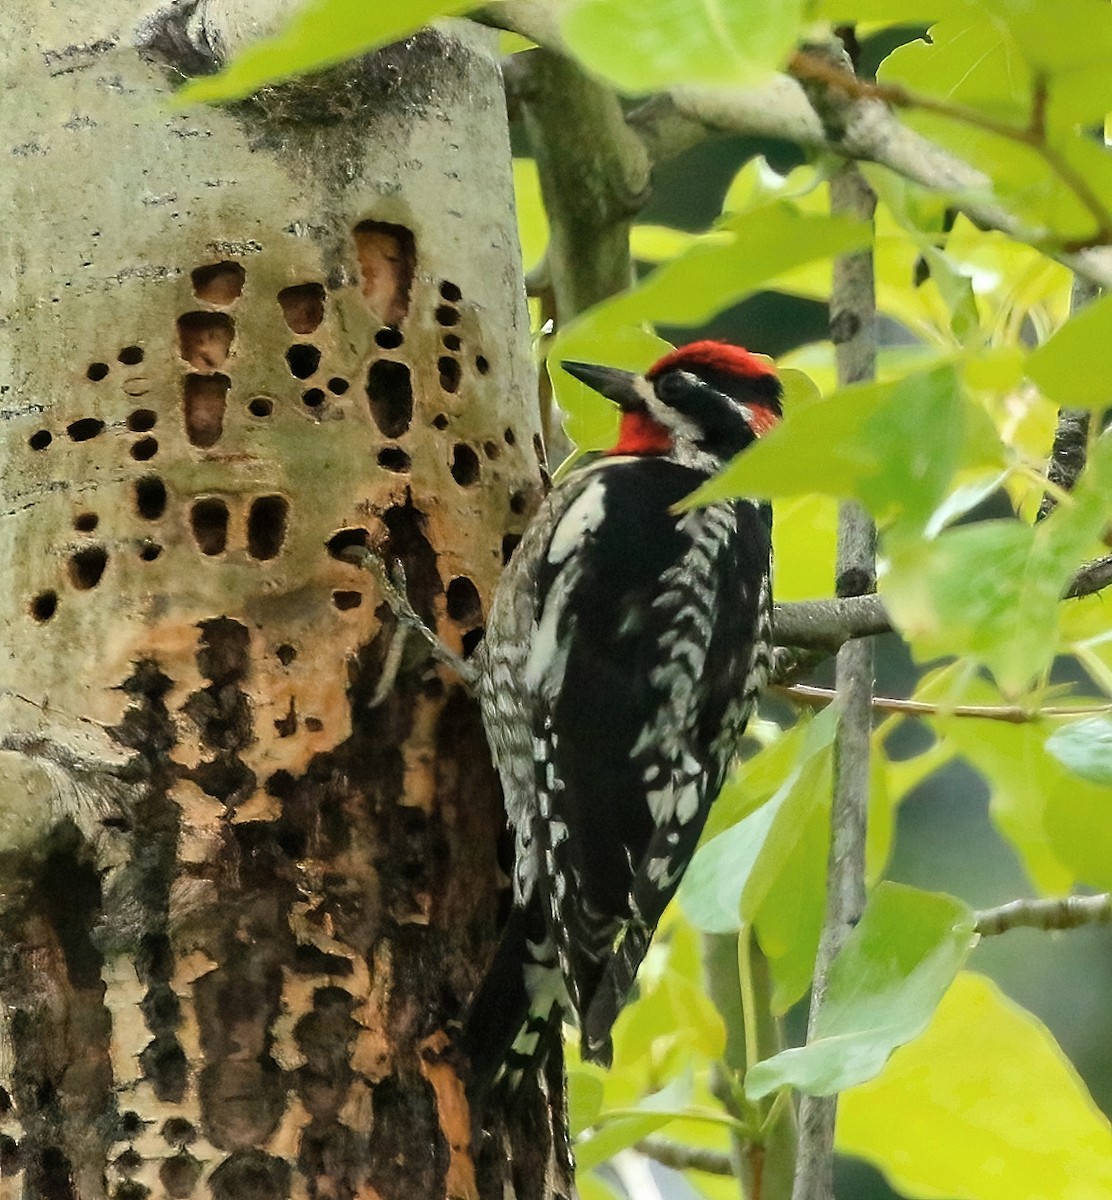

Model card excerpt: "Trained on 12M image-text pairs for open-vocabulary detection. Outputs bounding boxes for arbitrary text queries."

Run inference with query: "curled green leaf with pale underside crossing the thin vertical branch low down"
[745,883,976,1100]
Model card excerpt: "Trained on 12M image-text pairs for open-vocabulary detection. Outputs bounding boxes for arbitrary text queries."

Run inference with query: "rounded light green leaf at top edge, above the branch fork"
[561,0,804,94]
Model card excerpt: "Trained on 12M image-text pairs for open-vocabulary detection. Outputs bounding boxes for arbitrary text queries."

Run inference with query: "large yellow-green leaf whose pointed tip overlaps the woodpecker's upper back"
[692,365,1000,530]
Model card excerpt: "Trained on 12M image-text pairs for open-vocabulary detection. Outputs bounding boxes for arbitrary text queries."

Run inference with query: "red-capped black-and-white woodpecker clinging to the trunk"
[461,341,783,1102]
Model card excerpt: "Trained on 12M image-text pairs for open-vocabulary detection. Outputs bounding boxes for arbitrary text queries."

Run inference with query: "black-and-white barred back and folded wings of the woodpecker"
[525,458,768,1058]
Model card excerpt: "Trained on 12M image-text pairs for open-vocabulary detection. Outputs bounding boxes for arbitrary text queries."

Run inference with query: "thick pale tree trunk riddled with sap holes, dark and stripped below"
[0,0,571,1200]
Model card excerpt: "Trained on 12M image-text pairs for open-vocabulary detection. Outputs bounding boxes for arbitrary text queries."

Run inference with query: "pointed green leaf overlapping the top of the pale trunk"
[178,0,475,104]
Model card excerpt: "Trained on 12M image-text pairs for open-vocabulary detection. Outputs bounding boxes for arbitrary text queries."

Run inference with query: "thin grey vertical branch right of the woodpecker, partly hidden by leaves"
[792,152,877,1200]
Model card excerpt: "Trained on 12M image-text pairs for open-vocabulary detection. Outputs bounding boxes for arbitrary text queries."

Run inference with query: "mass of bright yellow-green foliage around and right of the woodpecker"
[193,7,1112,1200]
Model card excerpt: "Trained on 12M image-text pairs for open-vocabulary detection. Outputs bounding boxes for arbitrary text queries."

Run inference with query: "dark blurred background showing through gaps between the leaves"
[530,21,1112,1200]
